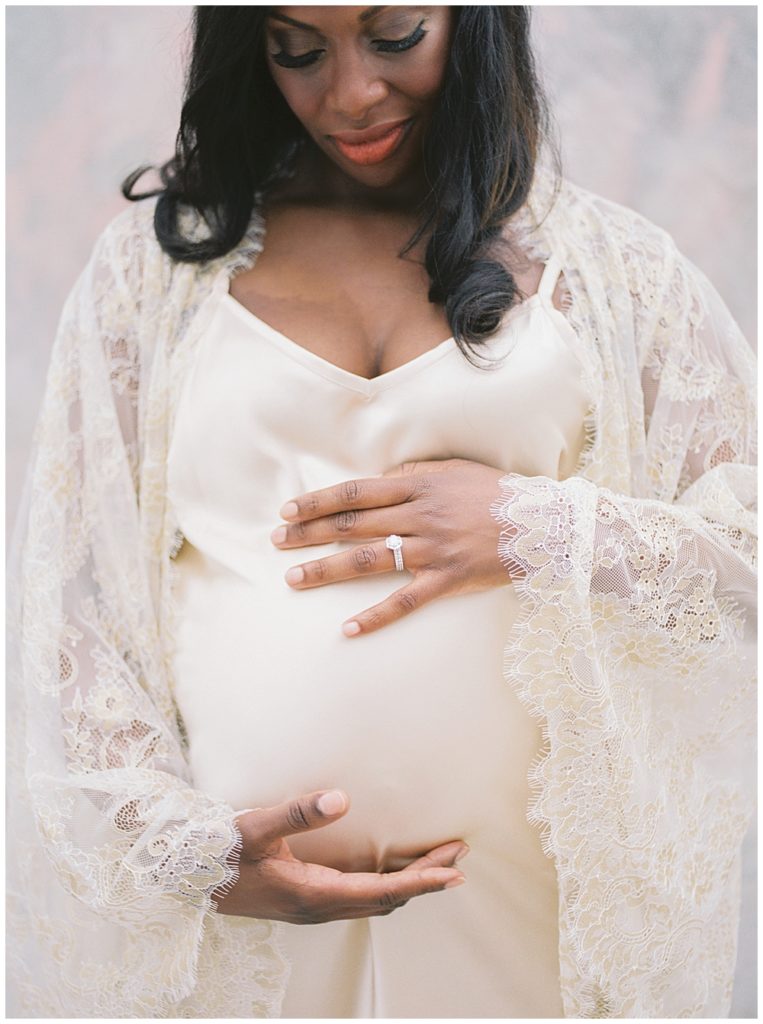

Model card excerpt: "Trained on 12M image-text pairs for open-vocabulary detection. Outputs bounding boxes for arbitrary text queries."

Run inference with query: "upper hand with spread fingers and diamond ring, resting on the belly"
[270,459,510,636]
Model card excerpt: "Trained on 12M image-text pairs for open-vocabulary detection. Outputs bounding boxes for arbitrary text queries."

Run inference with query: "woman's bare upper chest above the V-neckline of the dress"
[230,201,541,380]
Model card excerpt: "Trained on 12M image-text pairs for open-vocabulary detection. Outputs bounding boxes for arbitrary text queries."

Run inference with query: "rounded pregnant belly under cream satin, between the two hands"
[173,545,540,870]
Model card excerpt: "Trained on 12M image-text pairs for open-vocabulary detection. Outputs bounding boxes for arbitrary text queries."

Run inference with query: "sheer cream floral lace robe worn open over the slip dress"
[8,159,755,1018]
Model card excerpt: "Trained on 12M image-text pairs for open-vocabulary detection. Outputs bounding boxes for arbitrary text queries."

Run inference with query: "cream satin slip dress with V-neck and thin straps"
[169,256,590,1018]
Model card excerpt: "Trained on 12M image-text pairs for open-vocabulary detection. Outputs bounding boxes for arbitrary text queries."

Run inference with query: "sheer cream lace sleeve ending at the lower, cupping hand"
[11,211,248,1017]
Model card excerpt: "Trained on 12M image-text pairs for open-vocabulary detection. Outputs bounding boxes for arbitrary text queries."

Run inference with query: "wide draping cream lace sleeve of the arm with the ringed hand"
[492,237,756,1017]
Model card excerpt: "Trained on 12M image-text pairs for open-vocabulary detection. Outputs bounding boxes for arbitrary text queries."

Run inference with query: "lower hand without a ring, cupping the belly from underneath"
[210,790,469,925]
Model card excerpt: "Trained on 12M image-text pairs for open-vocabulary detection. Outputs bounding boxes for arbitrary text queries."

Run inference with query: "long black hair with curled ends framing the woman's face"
[122,5,558,357]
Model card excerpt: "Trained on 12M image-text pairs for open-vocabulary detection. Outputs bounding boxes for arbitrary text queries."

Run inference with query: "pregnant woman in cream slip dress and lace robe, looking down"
[10,6,755,1018]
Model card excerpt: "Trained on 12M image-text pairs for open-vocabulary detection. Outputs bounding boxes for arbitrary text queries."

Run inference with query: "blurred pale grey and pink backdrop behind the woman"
[6,5,757,1017]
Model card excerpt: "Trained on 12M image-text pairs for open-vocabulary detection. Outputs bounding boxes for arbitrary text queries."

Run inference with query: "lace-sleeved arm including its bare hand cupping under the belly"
[11,207,464,1017]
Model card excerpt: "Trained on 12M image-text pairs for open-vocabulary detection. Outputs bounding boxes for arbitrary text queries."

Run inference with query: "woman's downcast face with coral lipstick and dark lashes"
[265,6,452,196]
